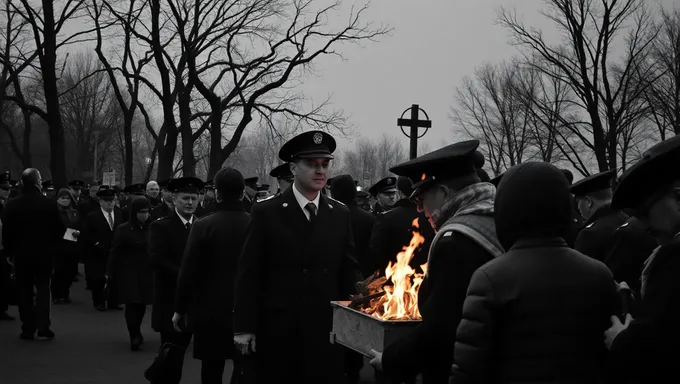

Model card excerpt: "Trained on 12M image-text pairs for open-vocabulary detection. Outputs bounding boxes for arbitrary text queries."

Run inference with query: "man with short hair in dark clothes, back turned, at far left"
[2,168,66,340]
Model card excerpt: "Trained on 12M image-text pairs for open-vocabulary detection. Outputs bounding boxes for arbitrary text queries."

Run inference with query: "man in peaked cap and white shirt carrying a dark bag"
[149,177,203,384]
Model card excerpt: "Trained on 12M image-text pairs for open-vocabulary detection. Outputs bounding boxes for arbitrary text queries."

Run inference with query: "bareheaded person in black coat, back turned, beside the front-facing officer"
[173,168,250,384]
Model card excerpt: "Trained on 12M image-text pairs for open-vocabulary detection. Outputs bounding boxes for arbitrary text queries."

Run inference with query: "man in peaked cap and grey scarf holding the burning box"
[371,140,503,384]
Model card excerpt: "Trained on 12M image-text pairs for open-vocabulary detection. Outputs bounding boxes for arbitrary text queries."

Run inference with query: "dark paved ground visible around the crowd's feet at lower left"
[0,268,372,384]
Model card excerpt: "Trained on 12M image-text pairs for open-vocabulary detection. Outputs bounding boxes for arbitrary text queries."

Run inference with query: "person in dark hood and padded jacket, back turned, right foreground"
[449,162,619,384]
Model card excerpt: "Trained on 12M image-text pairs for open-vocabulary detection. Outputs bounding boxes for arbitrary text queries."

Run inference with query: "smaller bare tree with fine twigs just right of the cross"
[451,61,532,174]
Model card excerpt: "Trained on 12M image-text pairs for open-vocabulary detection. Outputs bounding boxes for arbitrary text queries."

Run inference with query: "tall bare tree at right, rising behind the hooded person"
[499,0,659,171]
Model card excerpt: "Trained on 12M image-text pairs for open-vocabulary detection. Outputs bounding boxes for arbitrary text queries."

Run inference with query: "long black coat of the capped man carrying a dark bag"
[148,210,191,332]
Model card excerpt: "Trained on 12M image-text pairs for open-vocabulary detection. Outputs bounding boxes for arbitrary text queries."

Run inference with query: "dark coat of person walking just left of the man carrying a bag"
[107,221,153,304]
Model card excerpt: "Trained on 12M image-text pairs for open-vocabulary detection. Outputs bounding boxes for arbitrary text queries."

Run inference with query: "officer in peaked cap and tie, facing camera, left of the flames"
[234,131,362,384]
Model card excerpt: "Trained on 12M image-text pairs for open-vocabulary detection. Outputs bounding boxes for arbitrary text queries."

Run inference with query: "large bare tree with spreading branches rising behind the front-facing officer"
[179,0,388,179]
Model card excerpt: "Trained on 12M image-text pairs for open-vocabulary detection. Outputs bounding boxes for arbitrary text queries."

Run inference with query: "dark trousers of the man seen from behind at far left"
[15,259,53,333]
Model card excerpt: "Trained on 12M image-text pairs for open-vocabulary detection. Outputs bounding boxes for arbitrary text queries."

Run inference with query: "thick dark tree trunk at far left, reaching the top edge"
[40,0,67,190]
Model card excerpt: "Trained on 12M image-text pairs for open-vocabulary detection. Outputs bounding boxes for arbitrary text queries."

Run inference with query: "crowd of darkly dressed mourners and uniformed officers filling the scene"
[0,131,680,384]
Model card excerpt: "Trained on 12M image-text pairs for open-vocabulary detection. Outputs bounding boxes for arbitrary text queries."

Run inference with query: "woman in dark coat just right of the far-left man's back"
[50,188,80,304]
